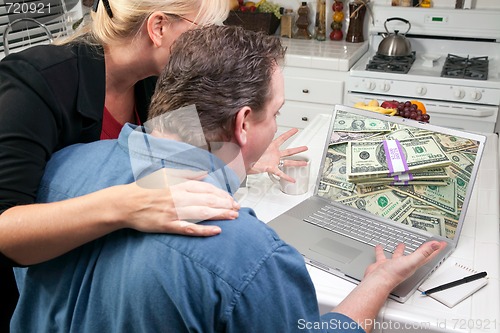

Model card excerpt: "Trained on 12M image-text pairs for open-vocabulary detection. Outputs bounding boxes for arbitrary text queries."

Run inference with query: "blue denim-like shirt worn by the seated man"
[11,125,362,333]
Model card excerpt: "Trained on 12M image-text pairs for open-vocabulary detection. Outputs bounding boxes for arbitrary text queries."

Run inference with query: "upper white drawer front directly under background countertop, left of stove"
[285,76,344,104]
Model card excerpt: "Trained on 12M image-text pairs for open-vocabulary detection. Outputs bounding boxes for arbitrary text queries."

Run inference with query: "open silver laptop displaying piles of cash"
[268,105,486,303]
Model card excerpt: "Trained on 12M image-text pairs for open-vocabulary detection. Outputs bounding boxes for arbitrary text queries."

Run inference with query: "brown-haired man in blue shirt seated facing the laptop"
[12,26,442,332]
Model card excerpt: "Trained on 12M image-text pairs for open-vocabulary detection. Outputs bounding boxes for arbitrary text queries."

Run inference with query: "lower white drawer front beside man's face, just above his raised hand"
[277,101,334,129]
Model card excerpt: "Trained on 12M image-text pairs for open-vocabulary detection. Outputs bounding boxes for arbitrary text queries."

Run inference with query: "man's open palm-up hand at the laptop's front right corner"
[365,241,446,290]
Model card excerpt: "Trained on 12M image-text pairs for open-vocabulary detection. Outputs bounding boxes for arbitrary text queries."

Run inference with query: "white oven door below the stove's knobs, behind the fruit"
[345,92,499,133]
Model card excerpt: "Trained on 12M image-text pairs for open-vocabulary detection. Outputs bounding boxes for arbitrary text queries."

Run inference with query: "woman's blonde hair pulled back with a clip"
[57,0,229,45]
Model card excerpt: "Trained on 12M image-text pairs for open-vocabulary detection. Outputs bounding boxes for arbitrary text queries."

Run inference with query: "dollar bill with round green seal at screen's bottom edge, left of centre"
[338,191,413,222]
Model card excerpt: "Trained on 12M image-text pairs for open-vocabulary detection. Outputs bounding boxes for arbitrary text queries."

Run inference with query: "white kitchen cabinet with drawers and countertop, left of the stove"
[277,38,368,133]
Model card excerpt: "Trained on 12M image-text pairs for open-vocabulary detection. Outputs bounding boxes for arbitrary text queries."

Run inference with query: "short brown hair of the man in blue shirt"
[149,26,285,142]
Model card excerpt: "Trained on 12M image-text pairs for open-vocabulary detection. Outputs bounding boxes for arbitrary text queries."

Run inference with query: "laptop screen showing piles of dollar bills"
[317,108,482,239]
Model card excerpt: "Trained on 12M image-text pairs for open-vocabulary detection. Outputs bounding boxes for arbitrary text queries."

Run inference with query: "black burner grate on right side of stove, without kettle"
[441,54,488,80]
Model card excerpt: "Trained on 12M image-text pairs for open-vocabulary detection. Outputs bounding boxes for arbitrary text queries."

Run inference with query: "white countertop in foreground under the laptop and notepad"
[240,114,500,333]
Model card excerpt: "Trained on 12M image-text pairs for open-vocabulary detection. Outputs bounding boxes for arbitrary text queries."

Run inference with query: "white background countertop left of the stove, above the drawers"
[281,38,368,72]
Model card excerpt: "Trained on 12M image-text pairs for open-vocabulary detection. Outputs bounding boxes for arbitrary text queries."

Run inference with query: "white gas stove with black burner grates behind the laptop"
[346,5,500,133]
